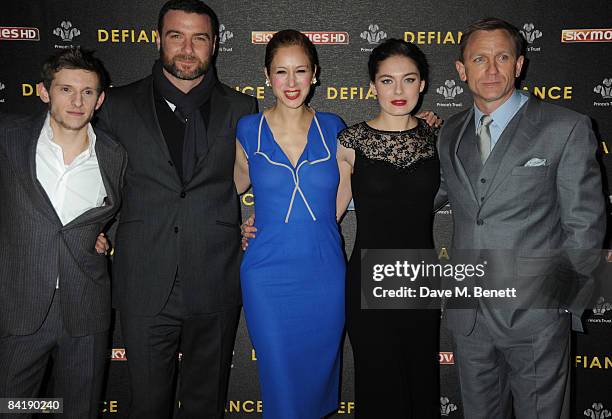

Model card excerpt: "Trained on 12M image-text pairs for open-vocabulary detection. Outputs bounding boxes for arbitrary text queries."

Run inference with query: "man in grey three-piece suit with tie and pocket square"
[436,18,605,419]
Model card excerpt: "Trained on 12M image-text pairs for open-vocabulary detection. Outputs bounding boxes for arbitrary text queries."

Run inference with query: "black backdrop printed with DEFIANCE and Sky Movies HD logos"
[0,0,612,419]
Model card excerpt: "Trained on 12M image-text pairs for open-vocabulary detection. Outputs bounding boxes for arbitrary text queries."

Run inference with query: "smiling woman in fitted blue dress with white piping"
[235,30,345,419]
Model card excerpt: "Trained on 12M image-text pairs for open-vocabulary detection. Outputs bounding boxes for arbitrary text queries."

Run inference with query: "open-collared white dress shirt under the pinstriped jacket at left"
[36,115,106,288]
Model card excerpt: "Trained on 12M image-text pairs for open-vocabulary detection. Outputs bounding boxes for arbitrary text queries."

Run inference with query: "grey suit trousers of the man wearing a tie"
[453,310,570,419]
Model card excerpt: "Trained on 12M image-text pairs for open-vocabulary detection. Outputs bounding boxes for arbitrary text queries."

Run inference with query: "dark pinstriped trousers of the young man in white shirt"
[0,290,108,419]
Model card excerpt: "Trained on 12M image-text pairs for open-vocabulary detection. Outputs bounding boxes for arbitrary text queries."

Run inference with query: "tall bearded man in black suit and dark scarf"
[99,0,257,419]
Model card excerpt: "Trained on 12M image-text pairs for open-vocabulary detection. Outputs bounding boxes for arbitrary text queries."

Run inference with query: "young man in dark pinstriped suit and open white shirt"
[0,48,127,419]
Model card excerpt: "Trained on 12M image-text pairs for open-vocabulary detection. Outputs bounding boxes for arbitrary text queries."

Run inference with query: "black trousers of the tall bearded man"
[121,279,240,419]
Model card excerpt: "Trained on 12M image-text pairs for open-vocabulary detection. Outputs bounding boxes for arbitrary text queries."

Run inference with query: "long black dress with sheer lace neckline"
[339,120,440,419]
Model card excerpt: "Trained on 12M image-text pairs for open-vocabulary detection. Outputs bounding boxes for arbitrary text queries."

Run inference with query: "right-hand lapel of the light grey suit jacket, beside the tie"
[483,97,540,203]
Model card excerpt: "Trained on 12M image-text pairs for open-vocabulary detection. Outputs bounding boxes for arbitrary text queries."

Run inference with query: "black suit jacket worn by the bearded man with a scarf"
[98,77,257,315]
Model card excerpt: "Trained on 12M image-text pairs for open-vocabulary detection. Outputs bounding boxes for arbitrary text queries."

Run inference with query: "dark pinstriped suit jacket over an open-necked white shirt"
[0,113,127,336]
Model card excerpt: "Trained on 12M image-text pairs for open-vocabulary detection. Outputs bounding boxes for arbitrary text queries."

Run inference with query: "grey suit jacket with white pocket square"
[436,96,605,335]
